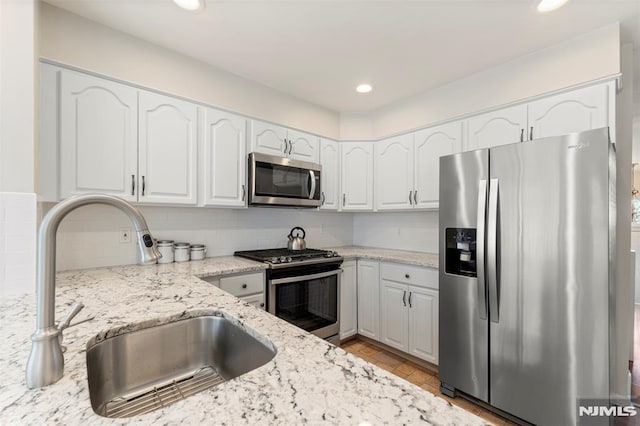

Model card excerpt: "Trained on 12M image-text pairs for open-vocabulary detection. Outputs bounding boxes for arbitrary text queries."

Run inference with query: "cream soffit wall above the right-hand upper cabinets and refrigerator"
[360,23,620,138]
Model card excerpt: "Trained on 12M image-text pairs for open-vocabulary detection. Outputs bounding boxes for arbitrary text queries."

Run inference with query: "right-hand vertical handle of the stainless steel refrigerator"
[487,178,500,323]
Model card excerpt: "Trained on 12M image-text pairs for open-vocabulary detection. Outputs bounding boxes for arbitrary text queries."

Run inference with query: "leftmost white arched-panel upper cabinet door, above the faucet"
[60,70,138,201]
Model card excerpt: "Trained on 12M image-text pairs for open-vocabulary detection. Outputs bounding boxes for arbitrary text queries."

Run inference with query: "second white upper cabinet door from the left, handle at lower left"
[138,91,198,204]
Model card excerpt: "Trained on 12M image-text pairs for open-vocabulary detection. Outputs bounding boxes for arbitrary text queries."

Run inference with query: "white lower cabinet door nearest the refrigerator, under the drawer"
[409,286,438,364]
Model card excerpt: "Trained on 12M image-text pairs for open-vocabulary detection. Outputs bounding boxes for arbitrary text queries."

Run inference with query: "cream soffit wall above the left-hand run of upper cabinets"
[40,2,339,139]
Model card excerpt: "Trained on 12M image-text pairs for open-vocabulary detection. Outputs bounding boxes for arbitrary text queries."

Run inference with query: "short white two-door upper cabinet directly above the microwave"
[251,120,320,163]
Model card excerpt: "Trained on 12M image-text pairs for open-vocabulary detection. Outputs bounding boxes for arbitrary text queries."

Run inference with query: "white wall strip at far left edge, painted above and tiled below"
[0,0,37,299]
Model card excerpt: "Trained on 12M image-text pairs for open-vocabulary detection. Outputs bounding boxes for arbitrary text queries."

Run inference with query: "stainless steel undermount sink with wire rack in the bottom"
[87,315,276,417]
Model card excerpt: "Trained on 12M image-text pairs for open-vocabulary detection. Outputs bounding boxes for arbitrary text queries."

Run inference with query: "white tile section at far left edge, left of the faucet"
[0,192,37,299]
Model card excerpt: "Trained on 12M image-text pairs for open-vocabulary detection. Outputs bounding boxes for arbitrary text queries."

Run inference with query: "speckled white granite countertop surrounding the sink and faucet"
[0,257,486,425]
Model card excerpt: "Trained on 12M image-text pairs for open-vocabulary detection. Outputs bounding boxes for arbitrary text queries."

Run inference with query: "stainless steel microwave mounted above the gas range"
[249,152,322,207]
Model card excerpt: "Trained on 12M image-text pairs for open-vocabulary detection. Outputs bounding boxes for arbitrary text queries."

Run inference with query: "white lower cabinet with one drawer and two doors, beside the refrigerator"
[378,262,438,364]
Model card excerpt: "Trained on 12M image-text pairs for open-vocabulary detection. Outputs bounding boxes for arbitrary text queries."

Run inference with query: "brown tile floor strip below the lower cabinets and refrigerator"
[340,338,516,426]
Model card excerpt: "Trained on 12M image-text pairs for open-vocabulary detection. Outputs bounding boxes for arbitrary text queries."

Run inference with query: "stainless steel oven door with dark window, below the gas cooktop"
[268,269,342,340]
